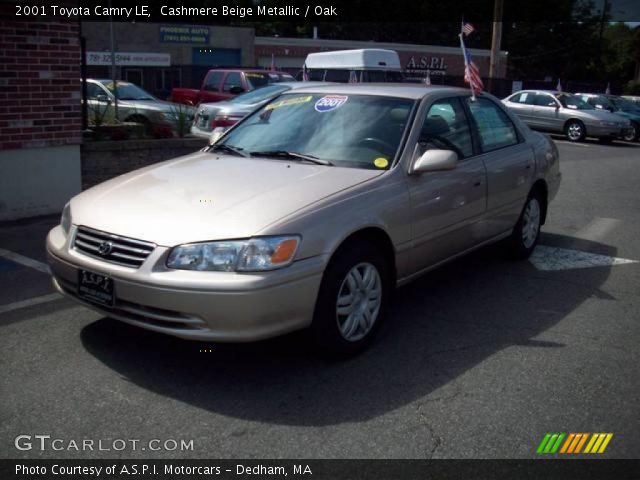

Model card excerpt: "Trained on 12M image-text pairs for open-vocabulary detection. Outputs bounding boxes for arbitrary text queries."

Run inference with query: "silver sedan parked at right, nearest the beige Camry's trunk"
[503,90,631,142]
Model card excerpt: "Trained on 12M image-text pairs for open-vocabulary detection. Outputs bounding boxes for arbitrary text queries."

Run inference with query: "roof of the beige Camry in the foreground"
[276,82,469,100]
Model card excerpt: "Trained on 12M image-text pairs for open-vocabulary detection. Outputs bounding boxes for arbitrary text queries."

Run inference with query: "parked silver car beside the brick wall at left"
[87,78,195,133]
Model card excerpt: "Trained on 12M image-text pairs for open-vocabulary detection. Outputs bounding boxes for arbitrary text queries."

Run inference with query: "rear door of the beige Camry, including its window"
[466,97,535,237]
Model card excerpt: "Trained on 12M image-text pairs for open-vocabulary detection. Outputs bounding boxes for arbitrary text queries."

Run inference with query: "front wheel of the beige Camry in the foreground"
[311,242,390,357]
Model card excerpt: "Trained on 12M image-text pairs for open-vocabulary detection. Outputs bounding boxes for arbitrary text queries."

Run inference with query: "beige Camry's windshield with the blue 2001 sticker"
[216,93,414,169]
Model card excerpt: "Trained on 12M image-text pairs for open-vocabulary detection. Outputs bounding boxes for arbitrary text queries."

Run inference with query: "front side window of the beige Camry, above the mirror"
[419,98,473,158]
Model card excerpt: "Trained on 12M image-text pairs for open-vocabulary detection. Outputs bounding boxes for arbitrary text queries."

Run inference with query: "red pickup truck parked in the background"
[171,69,295,105]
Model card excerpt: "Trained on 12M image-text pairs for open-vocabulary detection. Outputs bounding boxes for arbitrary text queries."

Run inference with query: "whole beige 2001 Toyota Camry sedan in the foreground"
[46,84,560,354]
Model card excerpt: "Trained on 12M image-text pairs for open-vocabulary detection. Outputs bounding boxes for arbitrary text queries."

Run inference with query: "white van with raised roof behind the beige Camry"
[305,48,402,83]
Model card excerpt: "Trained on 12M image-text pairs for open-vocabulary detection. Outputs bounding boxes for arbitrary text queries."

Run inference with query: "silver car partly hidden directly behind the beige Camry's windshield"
[191,82,330,139]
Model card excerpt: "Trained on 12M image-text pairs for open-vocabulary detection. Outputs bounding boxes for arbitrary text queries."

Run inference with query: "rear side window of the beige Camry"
[468,98,518,152]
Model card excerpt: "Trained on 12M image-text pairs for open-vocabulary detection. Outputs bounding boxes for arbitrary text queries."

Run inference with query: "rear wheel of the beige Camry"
[507,189,544,260]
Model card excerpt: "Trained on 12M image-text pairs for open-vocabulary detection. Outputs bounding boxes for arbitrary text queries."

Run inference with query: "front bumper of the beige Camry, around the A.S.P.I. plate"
[47,226,326,342]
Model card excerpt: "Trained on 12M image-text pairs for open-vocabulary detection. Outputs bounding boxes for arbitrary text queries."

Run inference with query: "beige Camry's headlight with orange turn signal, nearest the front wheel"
[167,235,300,272]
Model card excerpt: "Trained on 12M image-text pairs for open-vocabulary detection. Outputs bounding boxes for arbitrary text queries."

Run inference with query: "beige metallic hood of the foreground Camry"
[71,152,383,246]
